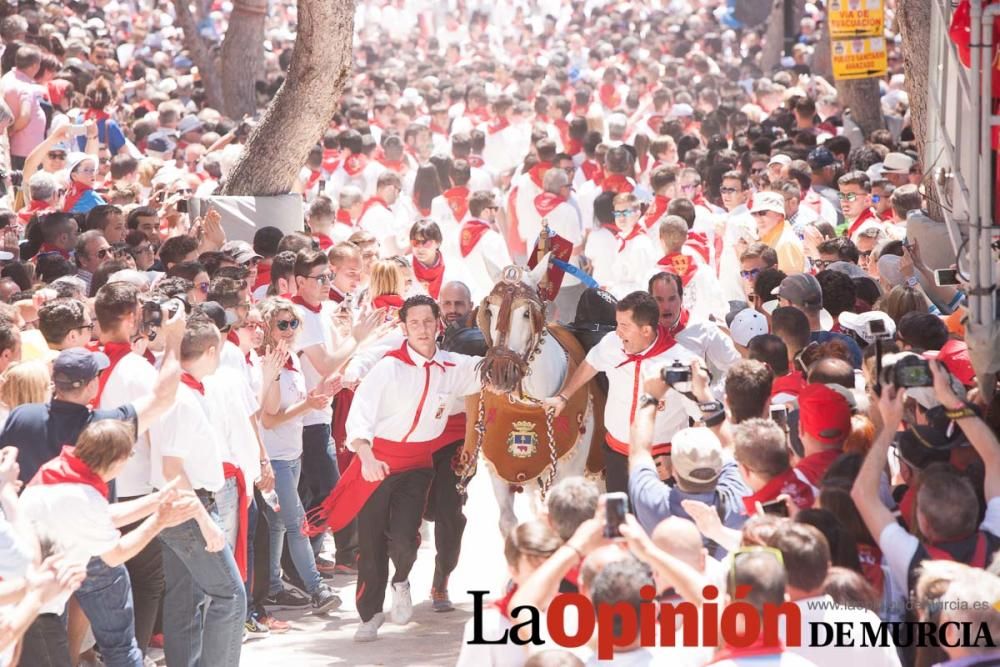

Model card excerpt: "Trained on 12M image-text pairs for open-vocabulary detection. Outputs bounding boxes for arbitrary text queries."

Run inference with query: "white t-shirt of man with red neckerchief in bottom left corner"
[19,484,121,614]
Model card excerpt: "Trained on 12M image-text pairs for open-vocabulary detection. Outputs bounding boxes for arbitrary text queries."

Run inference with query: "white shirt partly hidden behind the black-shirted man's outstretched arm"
[97,352,156,498]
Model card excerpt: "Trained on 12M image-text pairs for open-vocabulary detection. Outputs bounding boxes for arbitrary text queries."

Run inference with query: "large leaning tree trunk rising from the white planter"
[221,0,354,196]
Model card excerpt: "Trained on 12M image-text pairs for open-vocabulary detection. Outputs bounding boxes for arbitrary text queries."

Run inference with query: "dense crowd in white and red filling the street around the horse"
[0,0,1000,667]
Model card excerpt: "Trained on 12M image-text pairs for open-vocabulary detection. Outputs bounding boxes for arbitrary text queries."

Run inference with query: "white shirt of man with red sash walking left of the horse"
[347,344,482,446]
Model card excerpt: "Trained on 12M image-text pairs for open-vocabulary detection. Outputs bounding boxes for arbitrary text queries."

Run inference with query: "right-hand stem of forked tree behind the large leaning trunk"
[222,0,267,119]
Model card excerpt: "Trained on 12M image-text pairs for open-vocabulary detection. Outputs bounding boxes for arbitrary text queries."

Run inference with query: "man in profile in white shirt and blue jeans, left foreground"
[150,315,247,666]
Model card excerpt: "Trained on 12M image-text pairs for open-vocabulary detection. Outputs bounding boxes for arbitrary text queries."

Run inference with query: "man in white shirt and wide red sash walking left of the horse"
[342,295,481,642]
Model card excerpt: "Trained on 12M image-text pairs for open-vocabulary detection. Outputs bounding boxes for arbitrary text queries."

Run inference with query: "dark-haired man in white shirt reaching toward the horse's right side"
[545,292,701,492]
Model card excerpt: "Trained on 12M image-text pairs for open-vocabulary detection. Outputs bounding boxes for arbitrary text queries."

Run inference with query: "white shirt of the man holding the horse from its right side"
[587,332,701,452]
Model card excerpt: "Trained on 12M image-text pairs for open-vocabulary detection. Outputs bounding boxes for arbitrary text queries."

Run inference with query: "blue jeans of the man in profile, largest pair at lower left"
[160,502,247,667]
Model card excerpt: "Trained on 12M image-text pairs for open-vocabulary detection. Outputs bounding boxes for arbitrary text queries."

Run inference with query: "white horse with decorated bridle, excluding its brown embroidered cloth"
[470,257,594,537]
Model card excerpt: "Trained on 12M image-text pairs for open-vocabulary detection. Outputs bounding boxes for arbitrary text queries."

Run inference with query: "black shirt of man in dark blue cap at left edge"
[0,399,138,484]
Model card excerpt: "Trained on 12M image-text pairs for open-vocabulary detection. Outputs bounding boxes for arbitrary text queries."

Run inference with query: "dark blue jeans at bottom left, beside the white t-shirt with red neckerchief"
[75,556,143,667]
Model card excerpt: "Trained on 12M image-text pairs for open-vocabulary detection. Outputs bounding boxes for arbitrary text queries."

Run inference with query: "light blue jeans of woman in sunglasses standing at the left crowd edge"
[262,459,320,595]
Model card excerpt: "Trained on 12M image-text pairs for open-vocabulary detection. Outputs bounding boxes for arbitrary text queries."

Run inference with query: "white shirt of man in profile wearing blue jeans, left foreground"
[149,384,225,493]
